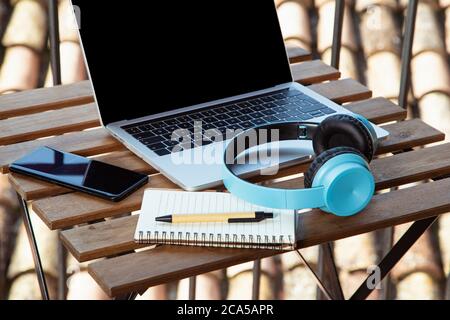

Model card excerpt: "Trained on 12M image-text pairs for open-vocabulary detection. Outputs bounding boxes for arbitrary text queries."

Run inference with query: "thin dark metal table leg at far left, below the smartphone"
[17,194,50,300]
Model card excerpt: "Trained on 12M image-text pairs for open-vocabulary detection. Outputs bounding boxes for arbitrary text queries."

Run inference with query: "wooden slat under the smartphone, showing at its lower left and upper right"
[8,151,156,201]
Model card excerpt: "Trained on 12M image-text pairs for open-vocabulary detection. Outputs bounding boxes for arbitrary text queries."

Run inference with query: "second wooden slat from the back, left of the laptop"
[0,103,100,145]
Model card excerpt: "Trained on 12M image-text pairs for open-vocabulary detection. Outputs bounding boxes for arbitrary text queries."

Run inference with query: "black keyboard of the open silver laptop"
[122,89,336,156]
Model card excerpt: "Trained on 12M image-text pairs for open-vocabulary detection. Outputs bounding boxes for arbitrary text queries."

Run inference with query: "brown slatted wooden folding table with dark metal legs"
[0,51,450,299]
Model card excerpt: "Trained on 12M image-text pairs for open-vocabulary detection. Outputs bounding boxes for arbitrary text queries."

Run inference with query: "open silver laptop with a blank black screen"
[73,0,388,191]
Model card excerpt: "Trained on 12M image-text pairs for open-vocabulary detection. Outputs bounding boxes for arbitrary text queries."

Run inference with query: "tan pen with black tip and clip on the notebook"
[155,211,273,223]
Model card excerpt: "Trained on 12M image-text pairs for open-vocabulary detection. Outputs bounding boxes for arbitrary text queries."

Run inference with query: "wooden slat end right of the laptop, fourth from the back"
[344,97,407,124]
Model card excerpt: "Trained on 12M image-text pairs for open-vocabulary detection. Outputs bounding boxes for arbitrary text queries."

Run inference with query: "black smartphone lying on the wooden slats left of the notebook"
[9,147,148,201]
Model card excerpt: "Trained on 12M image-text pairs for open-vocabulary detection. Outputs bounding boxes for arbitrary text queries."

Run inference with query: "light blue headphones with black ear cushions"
[222,114,377,216]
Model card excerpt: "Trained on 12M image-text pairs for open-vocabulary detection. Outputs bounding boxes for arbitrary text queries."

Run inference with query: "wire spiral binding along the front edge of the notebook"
[138,231,294,250]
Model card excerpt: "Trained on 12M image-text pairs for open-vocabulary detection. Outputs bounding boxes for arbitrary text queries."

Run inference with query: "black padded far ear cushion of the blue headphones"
[313,114,375,162]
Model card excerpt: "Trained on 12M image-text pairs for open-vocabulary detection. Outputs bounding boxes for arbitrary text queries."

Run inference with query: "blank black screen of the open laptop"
[73,0,292,125]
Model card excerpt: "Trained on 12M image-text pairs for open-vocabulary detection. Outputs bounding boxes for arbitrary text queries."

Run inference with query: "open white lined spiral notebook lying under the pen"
[134,189,296,250]
